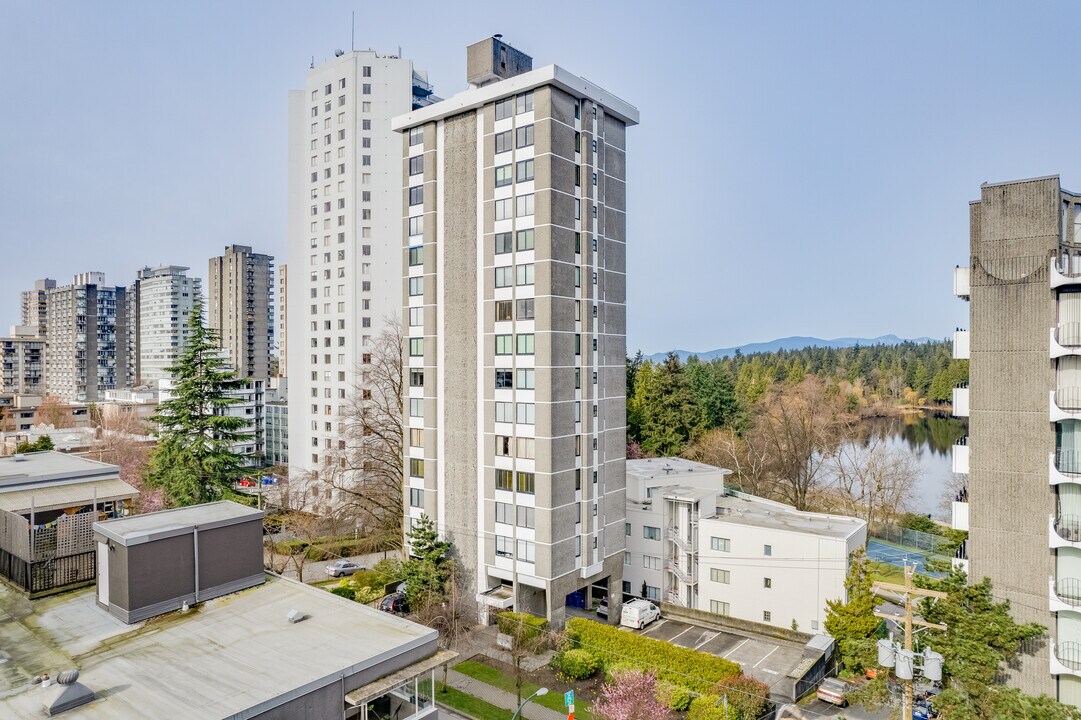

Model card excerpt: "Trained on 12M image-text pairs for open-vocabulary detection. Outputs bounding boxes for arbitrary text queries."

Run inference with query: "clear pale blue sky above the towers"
[0,0,1068,352]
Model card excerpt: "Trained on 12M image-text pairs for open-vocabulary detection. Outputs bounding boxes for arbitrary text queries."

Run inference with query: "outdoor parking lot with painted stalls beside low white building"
[638,618,803,688]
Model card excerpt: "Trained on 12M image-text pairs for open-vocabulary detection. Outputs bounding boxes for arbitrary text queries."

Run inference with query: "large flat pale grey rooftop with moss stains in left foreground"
[0,577,437,720]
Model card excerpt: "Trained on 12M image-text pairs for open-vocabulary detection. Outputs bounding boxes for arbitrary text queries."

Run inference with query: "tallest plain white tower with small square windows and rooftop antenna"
[285,50,432,484]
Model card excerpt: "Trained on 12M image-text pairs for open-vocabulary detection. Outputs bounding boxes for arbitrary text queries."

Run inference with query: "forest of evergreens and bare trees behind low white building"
[627,342,969,523]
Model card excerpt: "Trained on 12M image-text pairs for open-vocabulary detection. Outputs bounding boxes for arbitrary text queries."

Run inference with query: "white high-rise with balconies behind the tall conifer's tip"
[132,265,202,385]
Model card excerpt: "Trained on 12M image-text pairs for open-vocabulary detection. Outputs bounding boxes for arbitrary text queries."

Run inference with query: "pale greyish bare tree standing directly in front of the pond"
[832,436,920,526]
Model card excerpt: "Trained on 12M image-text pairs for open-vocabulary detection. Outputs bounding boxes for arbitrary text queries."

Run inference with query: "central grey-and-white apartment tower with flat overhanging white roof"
[393,38,638,624]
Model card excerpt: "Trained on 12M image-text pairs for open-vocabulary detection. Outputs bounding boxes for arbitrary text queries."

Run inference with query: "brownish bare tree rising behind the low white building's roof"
[755,376,853,510]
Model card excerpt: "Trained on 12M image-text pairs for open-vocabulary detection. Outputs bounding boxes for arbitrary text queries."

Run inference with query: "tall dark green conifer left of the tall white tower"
[146,302,251,506]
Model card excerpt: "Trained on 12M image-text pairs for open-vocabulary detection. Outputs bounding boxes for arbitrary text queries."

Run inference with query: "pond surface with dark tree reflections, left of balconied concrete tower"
[863,413,969,521]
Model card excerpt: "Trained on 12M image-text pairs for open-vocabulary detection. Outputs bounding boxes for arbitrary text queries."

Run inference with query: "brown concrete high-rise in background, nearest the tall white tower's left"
[206,245,275,379]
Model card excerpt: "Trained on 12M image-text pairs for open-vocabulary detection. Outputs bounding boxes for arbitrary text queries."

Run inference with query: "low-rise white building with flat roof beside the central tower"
[623,457,867,632]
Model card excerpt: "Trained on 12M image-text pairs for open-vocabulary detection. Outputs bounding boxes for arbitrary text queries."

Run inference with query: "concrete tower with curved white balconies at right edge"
[953,176,1081,705]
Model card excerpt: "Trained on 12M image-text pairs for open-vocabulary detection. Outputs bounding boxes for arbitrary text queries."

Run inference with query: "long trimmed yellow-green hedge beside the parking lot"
[566,617,739,693]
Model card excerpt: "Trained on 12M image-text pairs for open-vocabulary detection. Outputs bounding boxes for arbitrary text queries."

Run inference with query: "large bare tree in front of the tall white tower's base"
[321,320,405,544]
